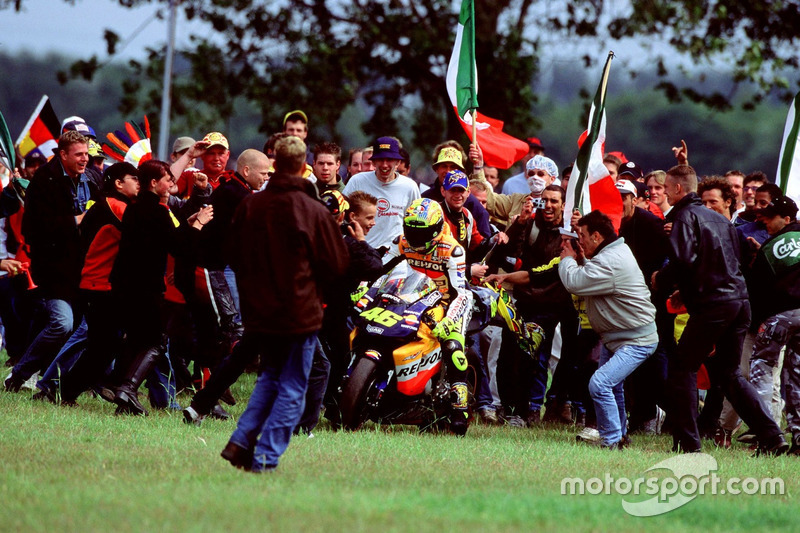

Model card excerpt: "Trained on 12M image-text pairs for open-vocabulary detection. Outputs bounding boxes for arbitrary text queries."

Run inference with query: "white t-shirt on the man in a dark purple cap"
[344,171,420,248]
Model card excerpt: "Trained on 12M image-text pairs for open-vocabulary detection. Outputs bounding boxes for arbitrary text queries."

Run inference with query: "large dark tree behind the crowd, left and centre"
[31,0,536,150]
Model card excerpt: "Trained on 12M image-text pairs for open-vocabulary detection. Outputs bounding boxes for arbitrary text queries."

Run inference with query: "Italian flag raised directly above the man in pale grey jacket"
[564,52,622,231]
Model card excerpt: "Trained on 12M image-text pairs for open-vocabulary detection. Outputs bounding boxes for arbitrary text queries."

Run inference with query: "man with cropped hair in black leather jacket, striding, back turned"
[652,165,789,455]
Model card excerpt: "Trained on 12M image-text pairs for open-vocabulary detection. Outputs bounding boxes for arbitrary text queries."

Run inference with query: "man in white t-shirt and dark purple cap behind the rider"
[344,137,420,249]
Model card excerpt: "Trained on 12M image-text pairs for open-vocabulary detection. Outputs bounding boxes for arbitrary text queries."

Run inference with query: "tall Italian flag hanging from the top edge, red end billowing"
[447,0,528,168]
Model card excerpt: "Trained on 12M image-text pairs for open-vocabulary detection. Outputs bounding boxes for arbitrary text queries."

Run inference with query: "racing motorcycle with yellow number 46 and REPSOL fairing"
[339,260,538,430]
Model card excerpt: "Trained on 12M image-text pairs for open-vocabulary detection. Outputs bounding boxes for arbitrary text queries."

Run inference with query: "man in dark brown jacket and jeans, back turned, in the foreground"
[222,137,348,472]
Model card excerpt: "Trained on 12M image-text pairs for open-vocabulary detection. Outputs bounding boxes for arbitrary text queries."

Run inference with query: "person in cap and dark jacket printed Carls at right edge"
[750,195,800,455]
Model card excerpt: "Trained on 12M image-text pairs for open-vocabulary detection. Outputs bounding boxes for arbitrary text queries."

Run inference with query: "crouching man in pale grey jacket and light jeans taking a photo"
[558,211,658,448]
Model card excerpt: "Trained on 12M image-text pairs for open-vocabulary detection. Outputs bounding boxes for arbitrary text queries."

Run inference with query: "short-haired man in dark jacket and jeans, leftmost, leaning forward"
[5,131,97,391]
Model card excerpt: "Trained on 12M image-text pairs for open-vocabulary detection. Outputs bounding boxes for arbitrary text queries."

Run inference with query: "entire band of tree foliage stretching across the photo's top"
[6,0,800,146]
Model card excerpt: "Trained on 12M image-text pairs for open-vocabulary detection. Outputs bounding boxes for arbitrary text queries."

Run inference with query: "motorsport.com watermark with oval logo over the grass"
[561,453,786,516]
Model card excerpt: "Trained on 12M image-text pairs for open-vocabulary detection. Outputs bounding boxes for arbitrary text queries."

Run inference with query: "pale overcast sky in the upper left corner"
[0,0,206,59]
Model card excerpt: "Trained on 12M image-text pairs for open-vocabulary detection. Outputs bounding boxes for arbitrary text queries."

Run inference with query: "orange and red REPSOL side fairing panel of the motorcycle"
[392,316,442,396]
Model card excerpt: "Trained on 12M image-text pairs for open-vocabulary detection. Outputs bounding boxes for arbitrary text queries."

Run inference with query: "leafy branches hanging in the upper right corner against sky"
[549,0,800,110]
